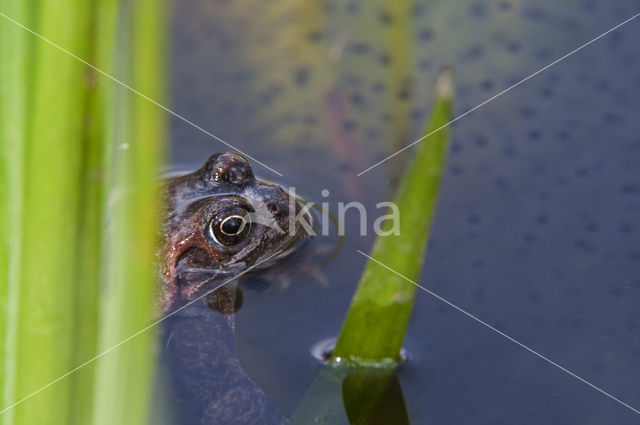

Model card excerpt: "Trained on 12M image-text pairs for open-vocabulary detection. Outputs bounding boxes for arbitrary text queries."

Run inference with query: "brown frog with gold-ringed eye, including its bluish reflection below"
[161,153,311,425]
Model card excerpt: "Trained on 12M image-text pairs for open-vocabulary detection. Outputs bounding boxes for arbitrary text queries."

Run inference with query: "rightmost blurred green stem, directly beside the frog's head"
[93,0,166,425]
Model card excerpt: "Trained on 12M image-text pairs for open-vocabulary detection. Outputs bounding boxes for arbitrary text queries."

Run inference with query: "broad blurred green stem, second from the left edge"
[10,0,94,424]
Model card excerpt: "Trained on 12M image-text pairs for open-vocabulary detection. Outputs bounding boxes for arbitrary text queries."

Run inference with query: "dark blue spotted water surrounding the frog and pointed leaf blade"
[171,0,640,425]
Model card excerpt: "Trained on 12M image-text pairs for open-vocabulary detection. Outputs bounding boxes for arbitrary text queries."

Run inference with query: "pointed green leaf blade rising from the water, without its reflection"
[333,71,453,364]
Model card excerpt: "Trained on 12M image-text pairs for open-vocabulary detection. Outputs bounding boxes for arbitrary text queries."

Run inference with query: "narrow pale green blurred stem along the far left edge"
[0,0,28,425]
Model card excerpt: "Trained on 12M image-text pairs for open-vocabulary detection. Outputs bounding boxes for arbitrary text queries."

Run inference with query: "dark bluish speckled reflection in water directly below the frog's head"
[162,289,286,425]
